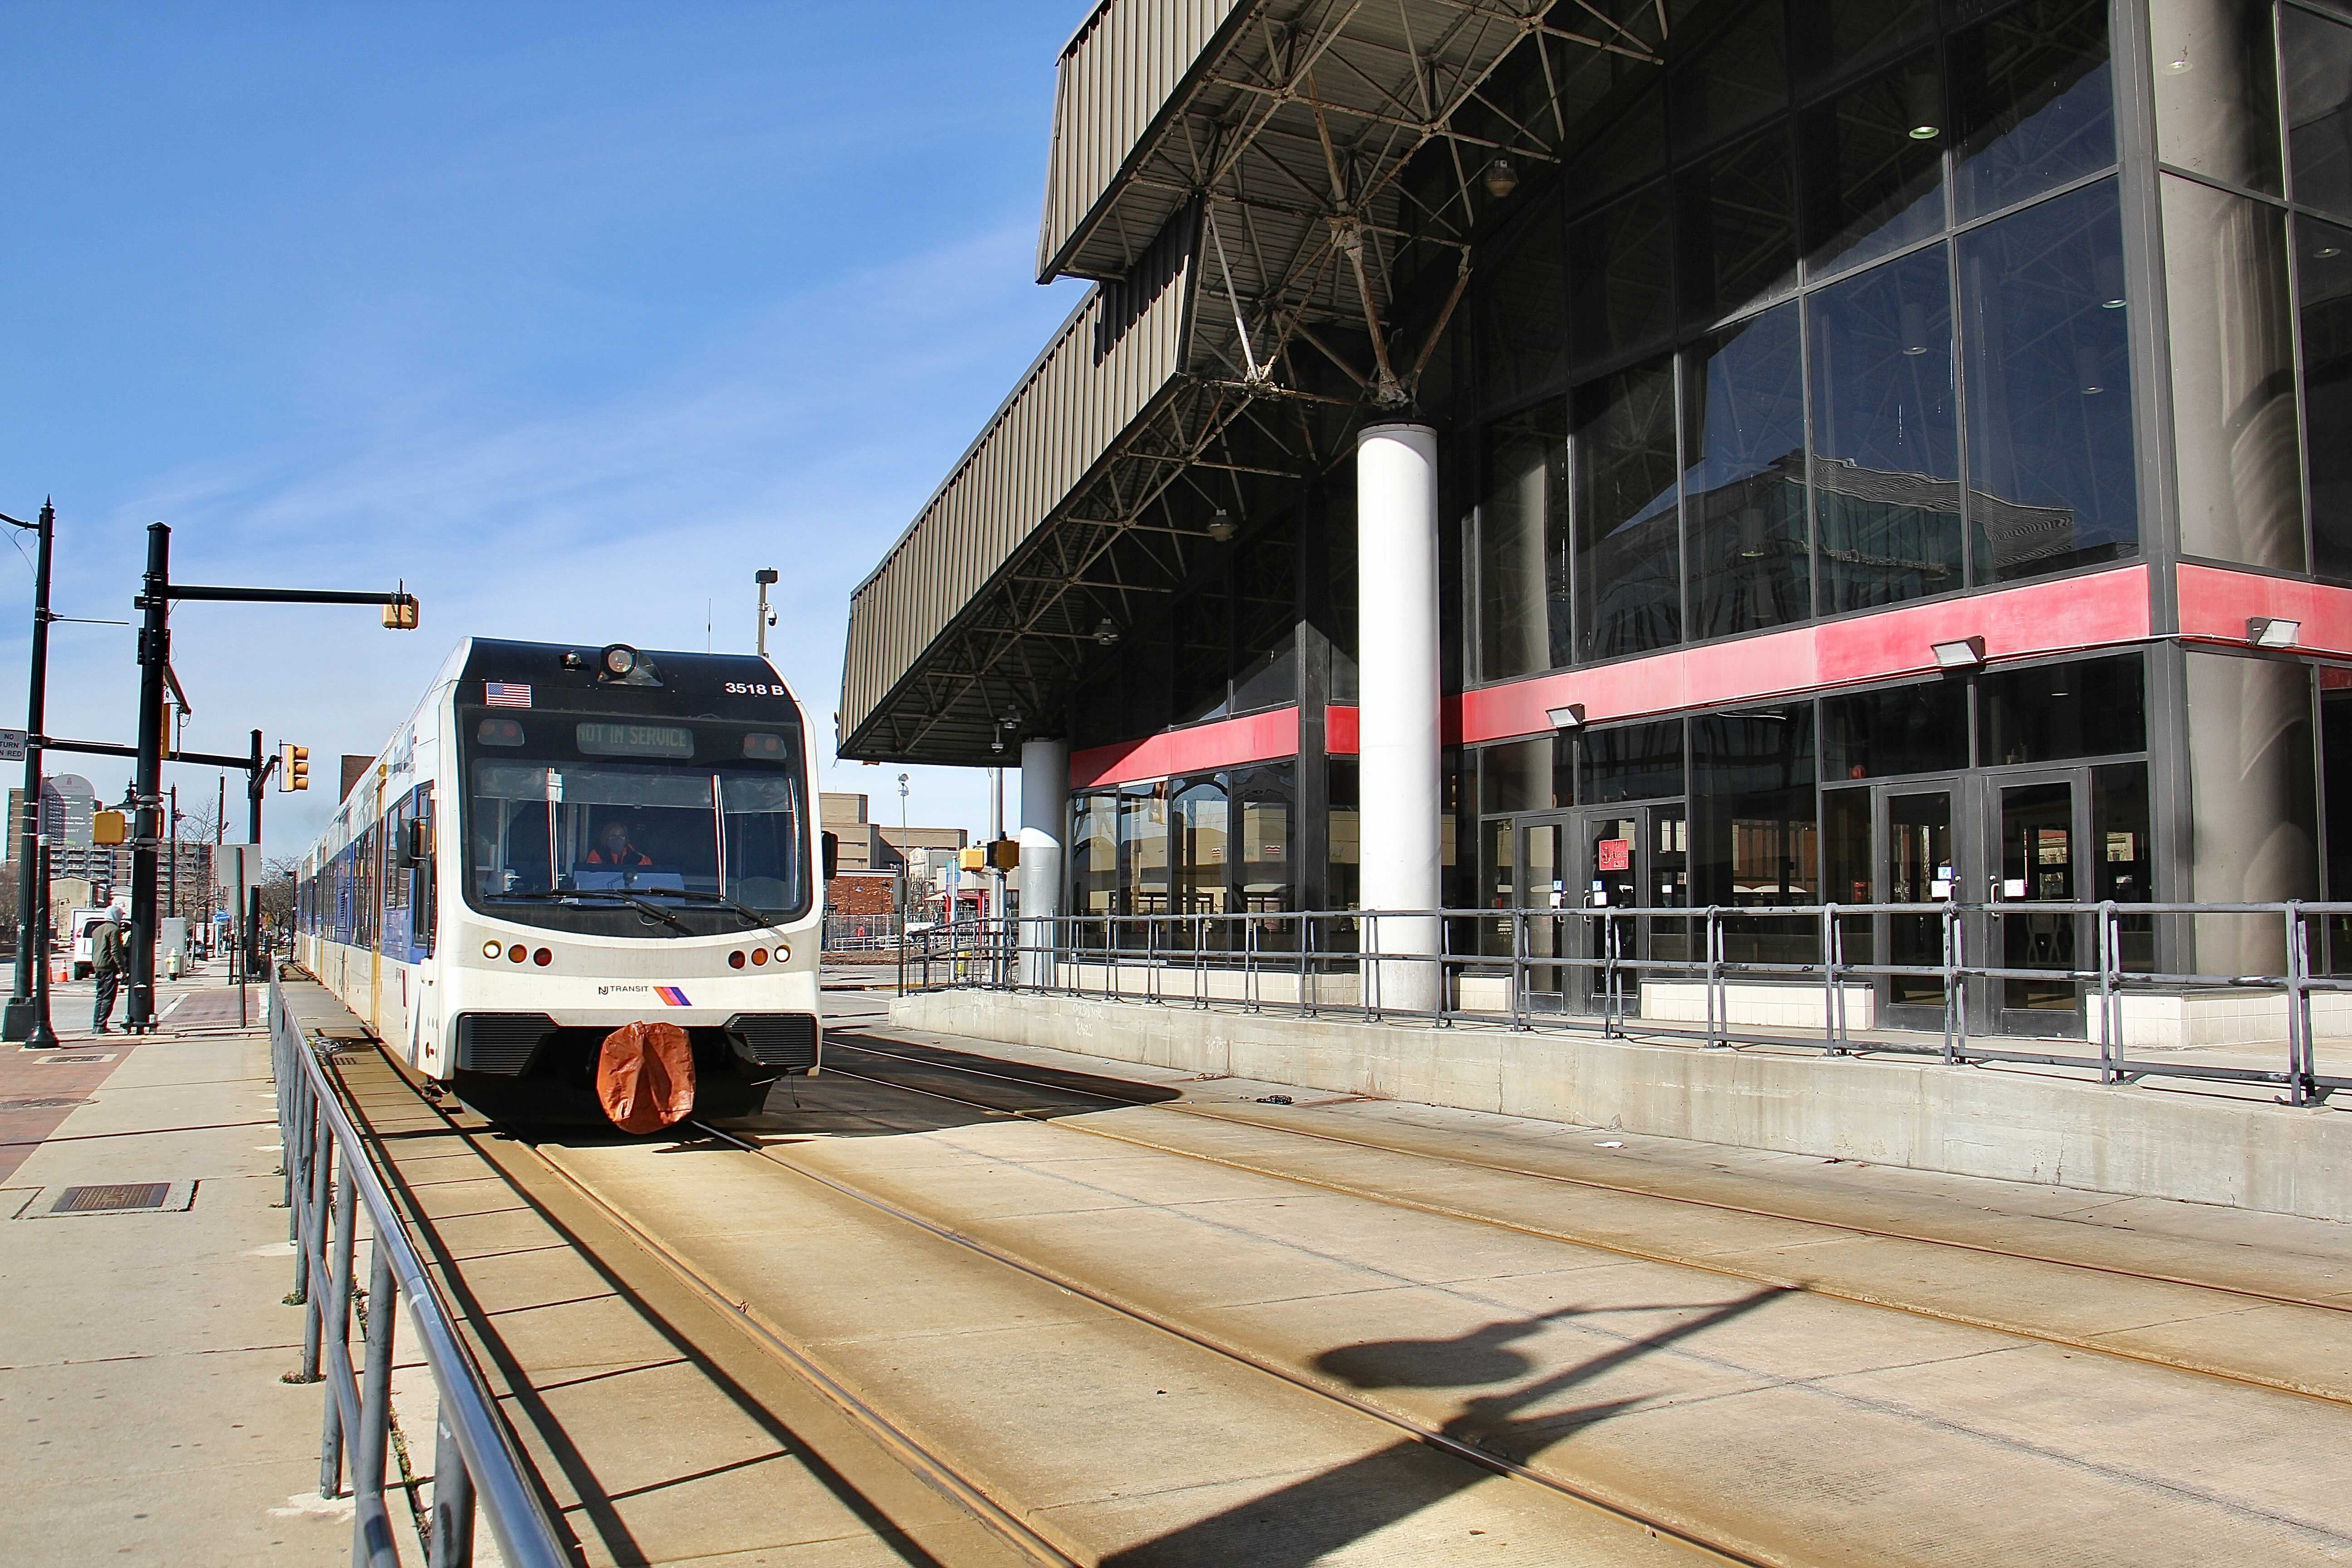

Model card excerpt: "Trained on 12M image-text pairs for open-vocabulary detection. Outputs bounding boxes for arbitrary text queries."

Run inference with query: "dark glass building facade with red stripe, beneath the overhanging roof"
[1039,0,2352,1032]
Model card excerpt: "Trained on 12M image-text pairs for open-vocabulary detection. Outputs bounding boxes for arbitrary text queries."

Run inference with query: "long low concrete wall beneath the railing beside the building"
[892,992,2352,1220]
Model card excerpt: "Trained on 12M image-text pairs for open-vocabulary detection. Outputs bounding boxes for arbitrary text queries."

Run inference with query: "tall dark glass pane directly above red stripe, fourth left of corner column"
[1571,360,1682,658]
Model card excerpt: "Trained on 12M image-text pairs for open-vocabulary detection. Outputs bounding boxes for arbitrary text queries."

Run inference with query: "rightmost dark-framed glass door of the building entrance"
[1987,771,2091,1037]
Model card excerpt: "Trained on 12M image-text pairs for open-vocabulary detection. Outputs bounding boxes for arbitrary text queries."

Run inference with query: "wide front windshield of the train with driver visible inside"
[461,712,811,938]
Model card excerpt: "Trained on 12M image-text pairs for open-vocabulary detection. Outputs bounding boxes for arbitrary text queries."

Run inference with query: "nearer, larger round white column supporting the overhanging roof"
[1355,426,1444,1011]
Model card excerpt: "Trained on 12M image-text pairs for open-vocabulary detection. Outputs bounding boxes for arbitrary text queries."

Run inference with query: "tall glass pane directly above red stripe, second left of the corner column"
[1808,247,1961,613]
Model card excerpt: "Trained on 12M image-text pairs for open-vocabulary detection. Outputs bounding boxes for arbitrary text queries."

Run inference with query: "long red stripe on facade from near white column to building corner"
[1449,567,2154,745]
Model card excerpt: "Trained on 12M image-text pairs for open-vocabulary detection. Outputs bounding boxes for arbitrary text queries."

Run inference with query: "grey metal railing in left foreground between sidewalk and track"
[268,980,572,1568]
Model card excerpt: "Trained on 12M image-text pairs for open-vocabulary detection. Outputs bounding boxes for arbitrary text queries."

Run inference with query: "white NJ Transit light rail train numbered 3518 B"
[296,637,826,1119]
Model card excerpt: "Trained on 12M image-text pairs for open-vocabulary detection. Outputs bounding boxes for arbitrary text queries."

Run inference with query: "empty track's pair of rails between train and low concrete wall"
[826,1032,2352,1406]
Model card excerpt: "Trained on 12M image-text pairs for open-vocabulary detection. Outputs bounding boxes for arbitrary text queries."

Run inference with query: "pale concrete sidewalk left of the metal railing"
[0,983,350,1568]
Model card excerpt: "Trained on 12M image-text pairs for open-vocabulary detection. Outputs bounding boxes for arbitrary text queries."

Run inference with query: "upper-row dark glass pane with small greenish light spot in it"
[1797,54,1945,275]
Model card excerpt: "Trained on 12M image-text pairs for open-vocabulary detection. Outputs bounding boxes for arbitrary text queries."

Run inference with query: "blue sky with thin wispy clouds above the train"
[0,0,1084,853]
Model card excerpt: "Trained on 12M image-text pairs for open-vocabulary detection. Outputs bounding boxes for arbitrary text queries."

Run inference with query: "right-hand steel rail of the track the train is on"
[677,1119,1771,1568]
